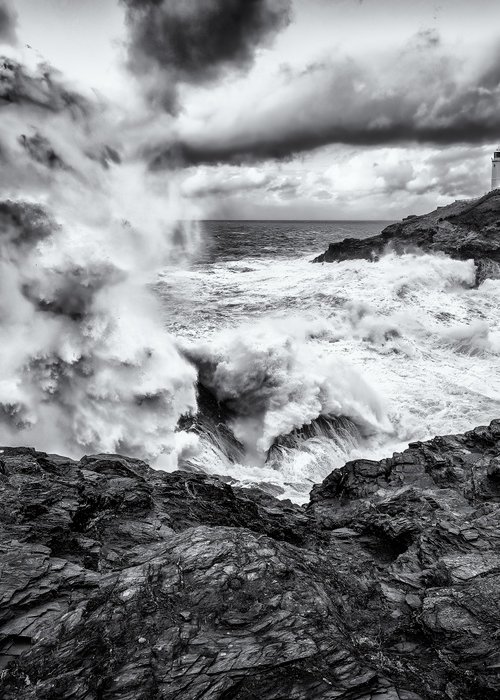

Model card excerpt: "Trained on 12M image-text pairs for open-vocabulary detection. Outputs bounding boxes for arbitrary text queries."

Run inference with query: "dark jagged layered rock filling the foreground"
[0,421,500,700]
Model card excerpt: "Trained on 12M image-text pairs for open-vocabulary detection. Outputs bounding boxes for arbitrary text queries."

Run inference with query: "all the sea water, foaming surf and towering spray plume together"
[0,60,500,502]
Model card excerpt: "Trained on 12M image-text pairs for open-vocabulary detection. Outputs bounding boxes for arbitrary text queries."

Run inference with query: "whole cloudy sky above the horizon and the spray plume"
[0,0,500,219]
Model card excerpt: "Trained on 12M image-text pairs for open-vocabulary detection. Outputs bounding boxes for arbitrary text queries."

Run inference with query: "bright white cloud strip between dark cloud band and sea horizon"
[182,146,490,219]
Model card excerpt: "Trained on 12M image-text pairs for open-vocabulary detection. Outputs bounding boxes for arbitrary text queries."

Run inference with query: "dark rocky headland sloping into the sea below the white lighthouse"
[313,190,500,284]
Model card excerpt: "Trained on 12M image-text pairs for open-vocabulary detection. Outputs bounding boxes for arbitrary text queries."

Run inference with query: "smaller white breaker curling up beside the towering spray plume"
[184,316,391,464]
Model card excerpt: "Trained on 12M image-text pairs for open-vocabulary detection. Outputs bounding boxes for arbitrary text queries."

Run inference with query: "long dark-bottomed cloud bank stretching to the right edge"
[150,41,500,168]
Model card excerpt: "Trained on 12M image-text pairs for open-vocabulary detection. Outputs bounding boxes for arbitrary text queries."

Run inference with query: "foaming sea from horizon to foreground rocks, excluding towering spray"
[157,221,500,502]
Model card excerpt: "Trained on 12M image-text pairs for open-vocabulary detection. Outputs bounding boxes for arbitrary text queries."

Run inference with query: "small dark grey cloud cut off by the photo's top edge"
[122,0,290,109]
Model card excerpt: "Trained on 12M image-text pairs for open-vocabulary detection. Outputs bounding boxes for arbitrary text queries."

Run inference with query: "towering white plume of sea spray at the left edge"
[0,60,197,466]
